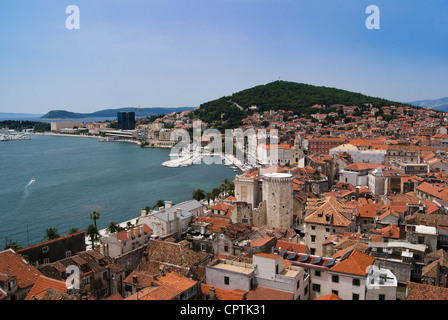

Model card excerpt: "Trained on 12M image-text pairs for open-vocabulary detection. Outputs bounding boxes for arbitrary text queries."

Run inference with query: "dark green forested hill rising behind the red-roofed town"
[192,81,412,129]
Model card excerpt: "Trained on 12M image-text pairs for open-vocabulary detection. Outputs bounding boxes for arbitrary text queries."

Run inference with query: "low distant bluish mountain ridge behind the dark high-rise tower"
[41,107,195,119]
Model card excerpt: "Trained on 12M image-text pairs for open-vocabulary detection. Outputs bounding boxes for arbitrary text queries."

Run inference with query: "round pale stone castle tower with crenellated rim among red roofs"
[262,173,293,228]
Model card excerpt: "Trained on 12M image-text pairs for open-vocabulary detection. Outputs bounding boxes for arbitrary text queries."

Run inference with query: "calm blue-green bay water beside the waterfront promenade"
[0,135,235,249]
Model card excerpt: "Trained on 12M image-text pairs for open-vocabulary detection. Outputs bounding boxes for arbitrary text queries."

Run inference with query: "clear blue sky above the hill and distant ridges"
[0,0,448,113]
